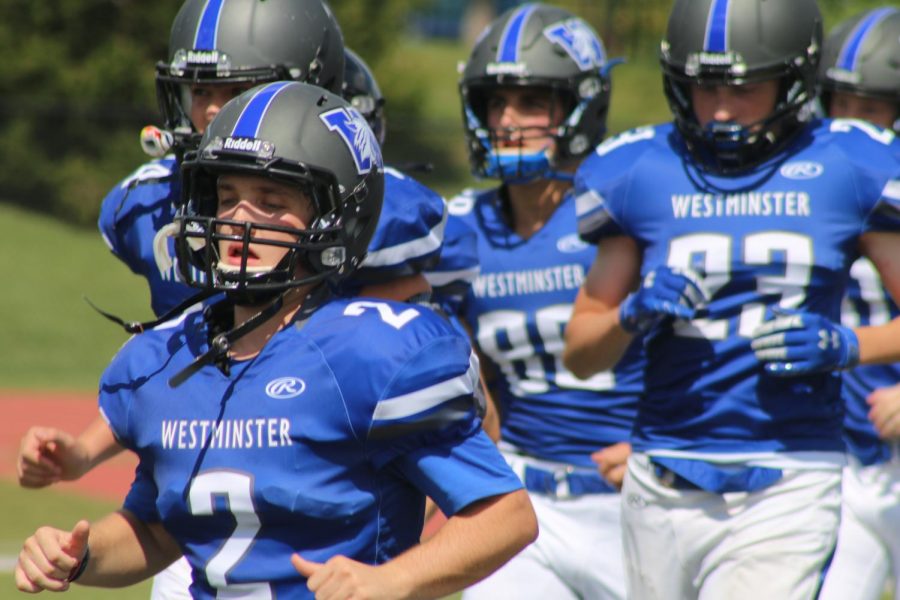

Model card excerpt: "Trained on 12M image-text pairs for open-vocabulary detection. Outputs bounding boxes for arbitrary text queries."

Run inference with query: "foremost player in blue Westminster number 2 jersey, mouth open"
[16,82,537,598]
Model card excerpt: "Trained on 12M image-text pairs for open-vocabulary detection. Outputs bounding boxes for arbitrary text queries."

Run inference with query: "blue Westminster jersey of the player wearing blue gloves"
[575,120,900,457]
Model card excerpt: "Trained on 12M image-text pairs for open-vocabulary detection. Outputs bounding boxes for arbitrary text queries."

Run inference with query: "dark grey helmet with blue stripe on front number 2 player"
[174,81,384,305]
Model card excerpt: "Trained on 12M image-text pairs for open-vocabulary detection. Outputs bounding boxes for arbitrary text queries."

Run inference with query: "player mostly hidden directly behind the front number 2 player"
[18,0,446,599]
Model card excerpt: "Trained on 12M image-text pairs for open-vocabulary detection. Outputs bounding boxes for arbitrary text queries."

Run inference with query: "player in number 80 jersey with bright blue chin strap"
[441,3,641,600]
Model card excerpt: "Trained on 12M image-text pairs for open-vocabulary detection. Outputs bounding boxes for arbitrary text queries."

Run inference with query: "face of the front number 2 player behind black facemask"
[216,175,315,269]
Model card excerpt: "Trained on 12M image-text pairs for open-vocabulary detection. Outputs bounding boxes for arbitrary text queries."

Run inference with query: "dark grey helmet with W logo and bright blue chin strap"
[459,3,620,182]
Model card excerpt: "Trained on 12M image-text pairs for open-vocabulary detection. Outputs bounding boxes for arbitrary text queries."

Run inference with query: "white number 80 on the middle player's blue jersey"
[478,304,616,396]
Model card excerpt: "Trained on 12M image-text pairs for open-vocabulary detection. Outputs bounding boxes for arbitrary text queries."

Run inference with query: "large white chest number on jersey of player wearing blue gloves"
[667,231,813,340]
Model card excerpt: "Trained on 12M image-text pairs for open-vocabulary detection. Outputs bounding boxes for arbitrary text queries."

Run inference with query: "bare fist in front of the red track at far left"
[16,427,89,488]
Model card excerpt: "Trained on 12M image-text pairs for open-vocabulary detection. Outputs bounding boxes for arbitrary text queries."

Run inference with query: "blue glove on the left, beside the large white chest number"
[619,266,708,334]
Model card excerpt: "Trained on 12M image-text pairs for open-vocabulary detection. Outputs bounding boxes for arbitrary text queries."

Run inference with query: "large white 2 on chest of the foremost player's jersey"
[188,469,274,600]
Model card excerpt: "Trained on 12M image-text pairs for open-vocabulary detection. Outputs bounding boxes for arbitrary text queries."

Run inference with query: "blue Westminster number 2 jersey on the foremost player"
[100,299,521,598]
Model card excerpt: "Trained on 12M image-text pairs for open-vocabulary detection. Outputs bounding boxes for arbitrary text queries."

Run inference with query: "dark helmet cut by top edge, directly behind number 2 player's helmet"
[156,0,344,152]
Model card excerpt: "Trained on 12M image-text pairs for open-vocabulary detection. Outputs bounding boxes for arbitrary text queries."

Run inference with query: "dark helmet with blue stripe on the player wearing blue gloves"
[660,0,822,172]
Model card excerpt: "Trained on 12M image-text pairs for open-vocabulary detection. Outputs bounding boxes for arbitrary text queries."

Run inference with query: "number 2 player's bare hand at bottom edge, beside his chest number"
[291,554,405,600]
